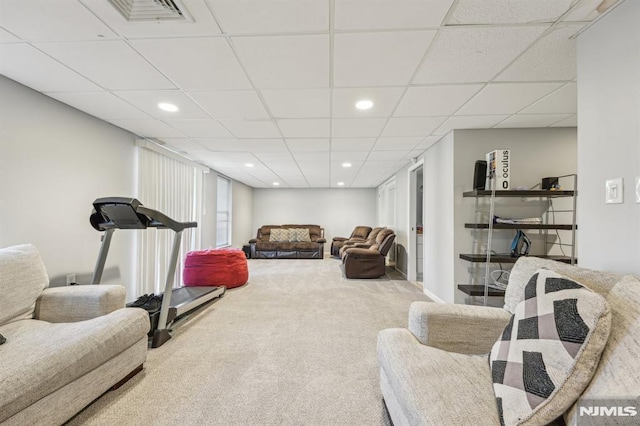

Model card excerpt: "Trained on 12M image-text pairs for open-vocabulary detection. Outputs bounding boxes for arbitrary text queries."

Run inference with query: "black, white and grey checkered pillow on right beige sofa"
[489,269,611,425]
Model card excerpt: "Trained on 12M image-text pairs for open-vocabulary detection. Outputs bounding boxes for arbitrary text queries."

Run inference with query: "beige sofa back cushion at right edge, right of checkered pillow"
[565,275,640,425]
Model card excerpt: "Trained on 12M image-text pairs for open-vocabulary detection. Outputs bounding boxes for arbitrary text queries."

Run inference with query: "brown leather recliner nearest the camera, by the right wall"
[341,229,396,278]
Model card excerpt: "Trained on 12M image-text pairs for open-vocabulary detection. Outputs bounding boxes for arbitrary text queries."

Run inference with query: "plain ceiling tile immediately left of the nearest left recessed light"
[47,92,151,120]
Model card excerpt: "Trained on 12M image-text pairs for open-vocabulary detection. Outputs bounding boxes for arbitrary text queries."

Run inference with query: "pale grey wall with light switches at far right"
[578,1,640,273]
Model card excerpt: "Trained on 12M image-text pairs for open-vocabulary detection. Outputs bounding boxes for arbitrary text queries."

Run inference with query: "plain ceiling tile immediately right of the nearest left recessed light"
[187,90,269,120]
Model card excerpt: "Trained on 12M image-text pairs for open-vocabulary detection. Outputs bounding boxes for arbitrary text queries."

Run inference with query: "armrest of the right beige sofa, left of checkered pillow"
[409,302,511,354]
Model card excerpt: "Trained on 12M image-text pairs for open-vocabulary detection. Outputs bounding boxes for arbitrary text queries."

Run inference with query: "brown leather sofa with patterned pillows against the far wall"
[249,225,326,259]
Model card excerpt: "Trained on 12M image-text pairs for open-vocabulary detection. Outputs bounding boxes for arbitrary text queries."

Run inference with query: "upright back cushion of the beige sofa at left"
[0,244,49,325]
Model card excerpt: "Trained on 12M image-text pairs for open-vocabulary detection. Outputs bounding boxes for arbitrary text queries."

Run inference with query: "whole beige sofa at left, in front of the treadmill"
[0,245,149,425]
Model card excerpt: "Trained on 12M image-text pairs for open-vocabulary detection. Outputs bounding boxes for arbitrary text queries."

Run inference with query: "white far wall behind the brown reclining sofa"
[251,188,376,251]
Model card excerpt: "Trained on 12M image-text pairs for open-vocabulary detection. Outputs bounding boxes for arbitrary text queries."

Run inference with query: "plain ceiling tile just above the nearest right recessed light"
[333,31,436,87]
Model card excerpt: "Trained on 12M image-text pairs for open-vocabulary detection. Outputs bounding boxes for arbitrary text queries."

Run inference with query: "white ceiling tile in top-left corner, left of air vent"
[0,0,116,41]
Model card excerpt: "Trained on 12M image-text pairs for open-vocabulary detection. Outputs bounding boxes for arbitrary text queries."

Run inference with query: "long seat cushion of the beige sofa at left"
[0,308,149,423]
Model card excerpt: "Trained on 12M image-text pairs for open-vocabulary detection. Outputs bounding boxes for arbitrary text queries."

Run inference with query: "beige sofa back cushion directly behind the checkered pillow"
[504,256,624,313]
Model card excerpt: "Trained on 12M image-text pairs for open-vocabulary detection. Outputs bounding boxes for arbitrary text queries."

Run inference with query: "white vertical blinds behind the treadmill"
[136,147,203,296]
